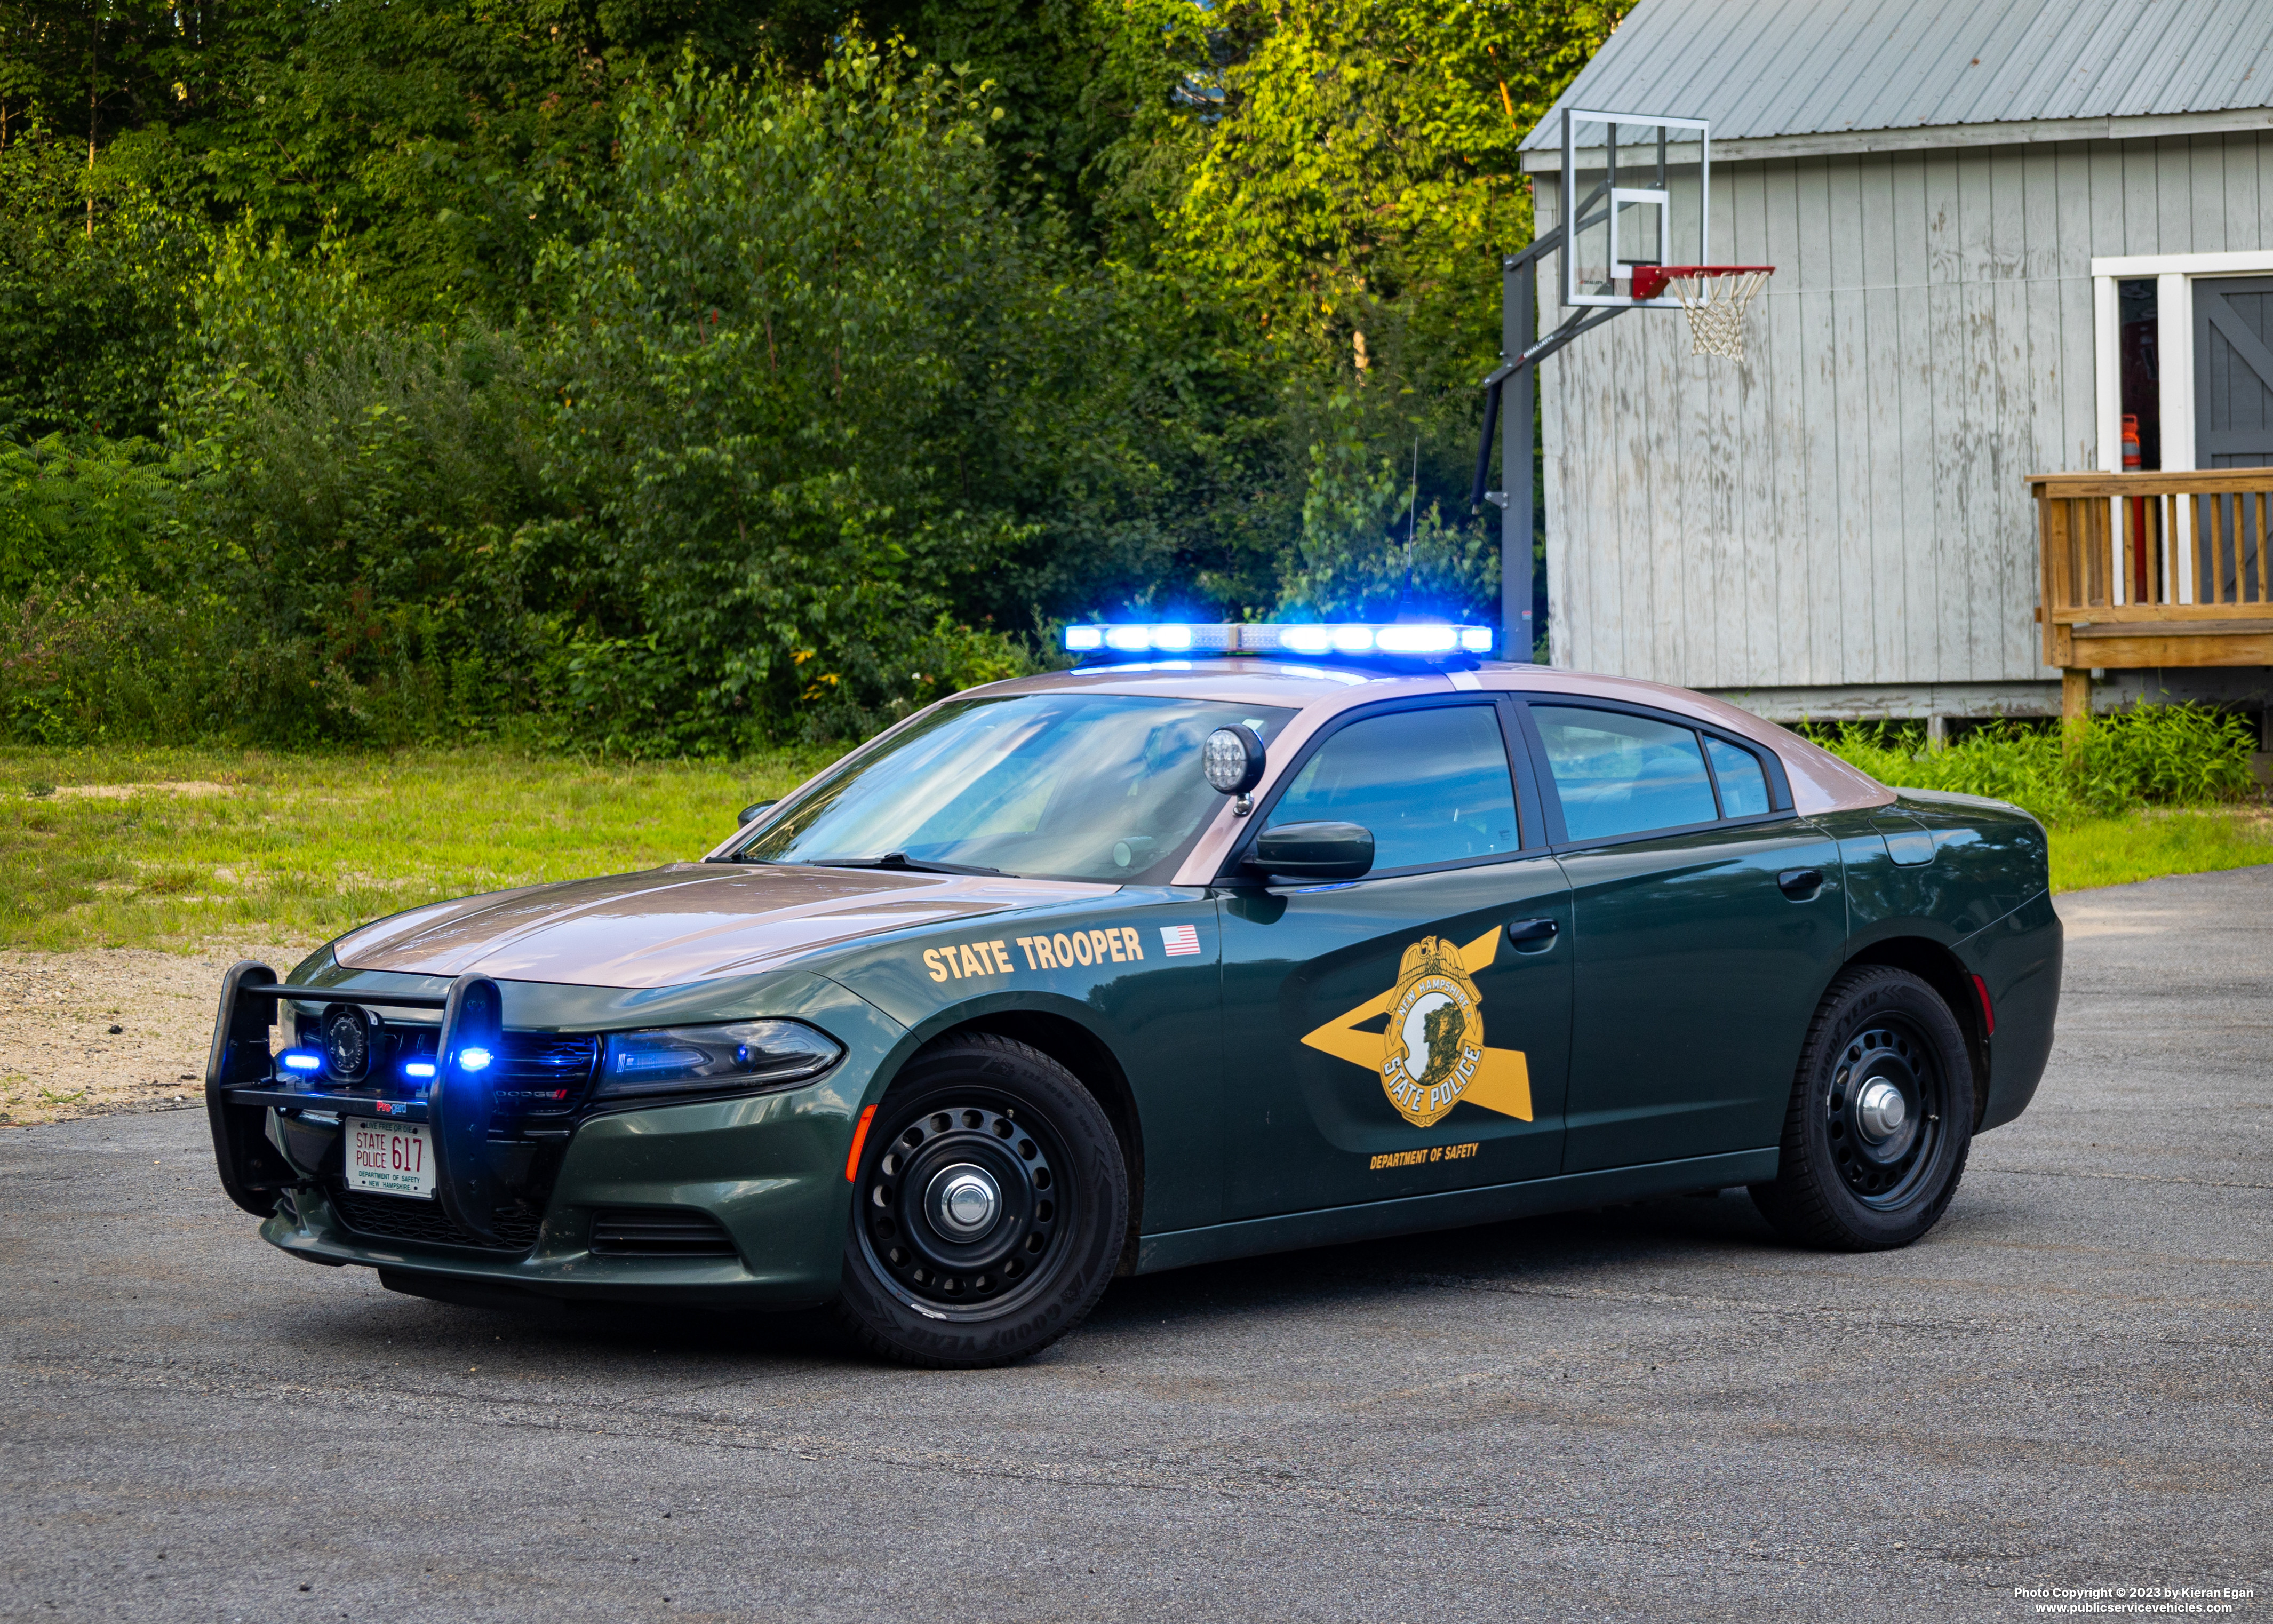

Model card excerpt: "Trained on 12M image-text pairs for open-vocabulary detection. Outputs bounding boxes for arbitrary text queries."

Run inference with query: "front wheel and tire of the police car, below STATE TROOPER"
[834,1033,1130,1370]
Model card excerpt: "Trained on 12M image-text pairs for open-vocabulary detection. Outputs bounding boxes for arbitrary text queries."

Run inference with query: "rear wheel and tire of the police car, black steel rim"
[1752,965,1973,1251]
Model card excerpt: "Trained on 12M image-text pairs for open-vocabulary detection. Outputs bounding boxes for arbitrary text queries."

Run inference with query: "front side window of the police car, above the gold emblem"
[1266,705,1523,871]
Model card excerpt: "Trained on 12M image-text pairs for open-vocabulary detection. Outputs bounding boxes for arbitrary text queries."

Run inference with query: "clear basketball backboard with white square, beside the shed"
[1561,107,1712,309]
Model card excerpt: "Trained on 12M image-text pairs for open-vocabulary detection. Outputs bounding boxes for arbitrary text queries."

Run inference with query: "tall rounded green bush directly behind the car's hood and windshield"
[543,43,1100,751]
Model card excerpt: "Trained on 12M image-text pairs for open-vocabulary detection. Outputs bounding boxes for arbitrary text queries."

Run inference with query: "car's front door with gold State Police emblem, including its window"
[1221,696,1570,1217]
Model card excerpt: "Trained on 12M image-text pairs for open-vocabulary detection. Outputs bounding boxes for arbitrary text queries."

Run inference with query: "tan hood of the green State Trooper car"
[332,862,1118,987]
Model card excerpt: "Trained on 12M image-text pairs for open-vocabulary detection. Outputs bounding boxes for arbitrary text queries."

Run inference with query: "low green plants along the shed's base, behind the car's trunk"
[1812,705,2257,823]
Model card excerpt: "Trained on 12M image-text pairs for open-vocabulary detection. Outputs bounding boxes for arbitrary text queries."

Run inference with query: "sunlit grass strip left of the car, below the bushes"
[0,749,832,951]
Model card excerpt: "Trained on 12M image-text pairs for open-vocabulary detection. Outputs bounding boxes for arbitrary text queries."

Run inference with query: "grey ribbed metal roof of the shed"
[1523,0,2273,150]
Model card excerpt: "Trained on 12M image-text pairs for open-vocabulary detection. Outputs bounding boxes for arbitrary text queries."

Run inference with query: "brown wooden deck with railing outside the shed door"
[2030,468,2273,717]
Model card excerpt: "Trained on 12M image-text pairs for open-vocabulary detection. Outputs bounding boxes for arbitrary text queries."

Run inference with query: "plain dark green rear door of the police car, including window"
[1521,696,1846,1172]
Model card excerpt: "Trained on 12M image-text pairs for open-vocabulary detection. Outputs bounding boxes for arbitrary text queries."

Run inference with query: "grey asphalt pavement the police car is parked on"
[0,869,2273,1624]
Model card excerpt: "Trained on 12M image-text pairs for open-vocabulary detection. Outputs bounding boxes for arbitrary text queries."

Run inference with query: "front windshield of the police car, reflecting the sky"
[734,691,1294,882]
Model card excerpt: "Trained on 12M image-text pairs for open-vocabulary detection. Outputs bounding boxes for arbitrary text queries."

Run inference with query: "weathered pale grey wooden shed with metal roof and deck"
[1523,0,2273,719]
